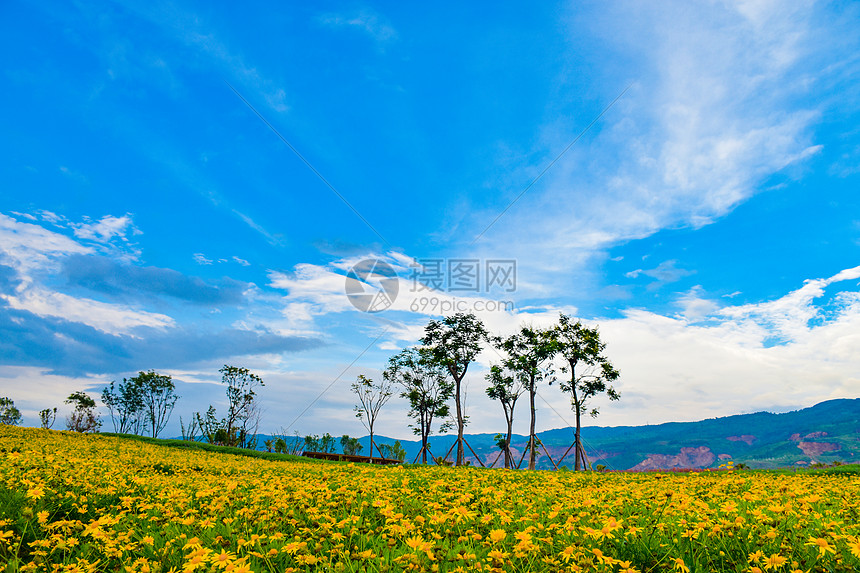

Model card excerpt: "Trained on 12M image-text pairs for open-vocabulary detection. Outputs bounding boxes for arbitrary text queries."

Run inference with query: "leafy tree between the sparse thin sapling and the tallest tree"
[383,348,454,464]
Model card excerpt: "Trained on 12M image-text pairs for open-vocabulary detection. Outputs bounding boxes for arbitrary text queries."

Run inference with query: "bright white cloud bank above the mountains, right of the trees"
[588,267,860,423]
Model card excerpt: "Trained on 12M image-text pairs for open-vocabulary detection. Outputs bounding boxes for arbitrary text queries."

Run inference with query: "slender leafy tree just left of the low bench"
[218,364,266,448]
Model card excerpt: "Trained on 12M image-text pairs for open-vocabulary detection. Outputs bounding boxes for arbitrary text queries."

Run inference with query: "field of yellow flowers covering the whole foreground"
[0,426,860,573]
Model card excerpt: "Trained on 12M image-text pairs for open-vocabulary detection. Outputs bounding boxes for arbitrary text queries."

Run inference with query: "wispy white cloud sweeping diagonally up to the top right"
[461,2,831,291]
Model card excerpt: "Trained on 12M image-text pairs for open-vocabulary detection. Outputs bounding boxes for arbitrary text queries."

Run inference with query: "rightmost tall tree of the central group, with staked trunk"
[550,313,621,470]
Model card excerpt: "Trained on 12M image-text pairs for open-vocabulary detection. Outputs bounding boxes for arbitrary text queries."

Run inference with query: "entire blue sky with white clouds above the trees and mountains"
[0,1,860,437]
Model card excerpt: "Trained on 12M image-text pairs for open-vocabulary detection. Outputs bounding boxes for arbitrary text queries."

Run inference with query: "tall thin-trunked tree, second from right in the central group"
[495,326,556,470]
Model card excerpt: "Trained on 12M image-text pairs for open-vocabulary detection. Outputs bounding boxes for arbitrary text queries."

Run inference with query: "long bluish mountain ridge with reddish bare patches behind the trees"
[372,399,860,471]
